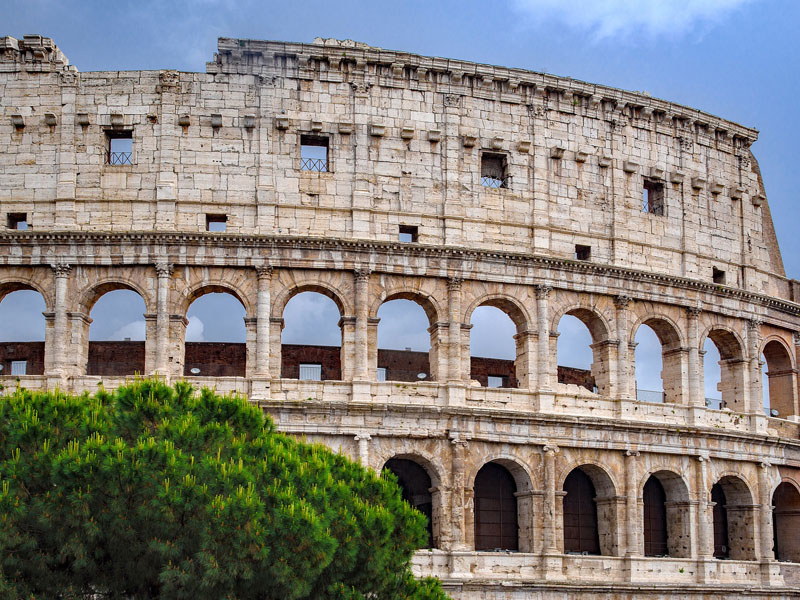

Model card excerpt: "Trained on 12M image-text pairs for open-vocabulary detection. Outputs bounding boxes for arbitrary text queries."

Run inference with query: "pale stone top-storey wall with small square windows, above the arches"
[0,36,793,299]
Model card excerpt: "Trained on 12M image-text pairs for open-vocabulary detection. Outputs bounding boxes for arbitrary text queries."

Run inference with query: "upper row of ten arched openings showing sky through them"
[0,270,797,416]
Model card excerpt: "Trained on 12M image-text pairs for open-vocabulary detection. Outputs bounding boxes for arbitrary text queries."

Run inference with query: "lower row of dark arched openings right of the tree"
[383,455,800,562]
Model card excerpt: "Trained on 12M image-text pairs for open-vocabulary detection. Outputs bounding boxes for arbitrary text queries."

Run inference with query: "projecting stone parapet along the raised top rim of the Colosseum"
[206,37,758,145]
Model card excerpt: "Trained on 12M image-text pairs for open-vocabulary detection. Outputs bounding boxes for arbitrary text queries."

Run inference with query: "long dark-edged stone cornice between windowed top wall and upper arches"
[0,230,800,316]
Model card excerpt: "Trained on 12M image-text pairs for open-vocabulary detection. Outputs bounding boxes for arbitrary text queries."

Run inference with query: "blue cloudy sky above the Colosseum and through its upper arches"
[0,0,788,404]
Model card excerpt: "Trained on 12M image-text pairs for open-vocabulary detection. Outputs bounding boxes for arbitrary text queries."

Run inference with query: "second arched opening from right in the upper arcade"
[701,329,746,412]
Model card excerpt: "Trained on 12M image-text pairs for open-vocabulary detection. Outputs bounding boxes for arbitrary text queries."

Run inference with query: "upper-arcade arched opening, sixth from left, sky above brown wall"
[469,304,518,388]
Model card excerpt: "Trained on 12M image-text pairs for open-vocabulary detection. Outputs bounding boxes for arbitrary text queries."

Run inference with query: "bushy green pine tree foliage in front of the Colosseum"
[0,380,446,600]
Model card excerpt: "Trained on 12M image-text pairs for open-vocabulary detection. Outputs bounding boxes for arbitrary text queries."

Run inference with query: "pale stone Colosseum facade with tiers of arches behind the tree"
[0,35,800,600]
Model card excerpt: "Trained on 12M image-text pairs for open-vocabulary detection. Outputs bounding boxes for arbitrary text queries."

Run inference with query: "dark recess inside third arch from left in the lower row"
[564,469,600,554]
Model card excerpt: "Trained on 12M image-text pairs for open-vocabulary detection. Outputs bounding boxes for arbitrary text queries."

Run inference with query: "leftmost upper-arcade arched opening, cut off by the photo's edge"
[0,288,47,377]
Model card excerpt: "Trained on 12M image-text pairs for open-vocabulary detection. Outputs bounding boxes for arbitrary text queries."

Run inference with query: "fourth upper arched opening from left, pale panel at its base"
[281,291,343,381]
